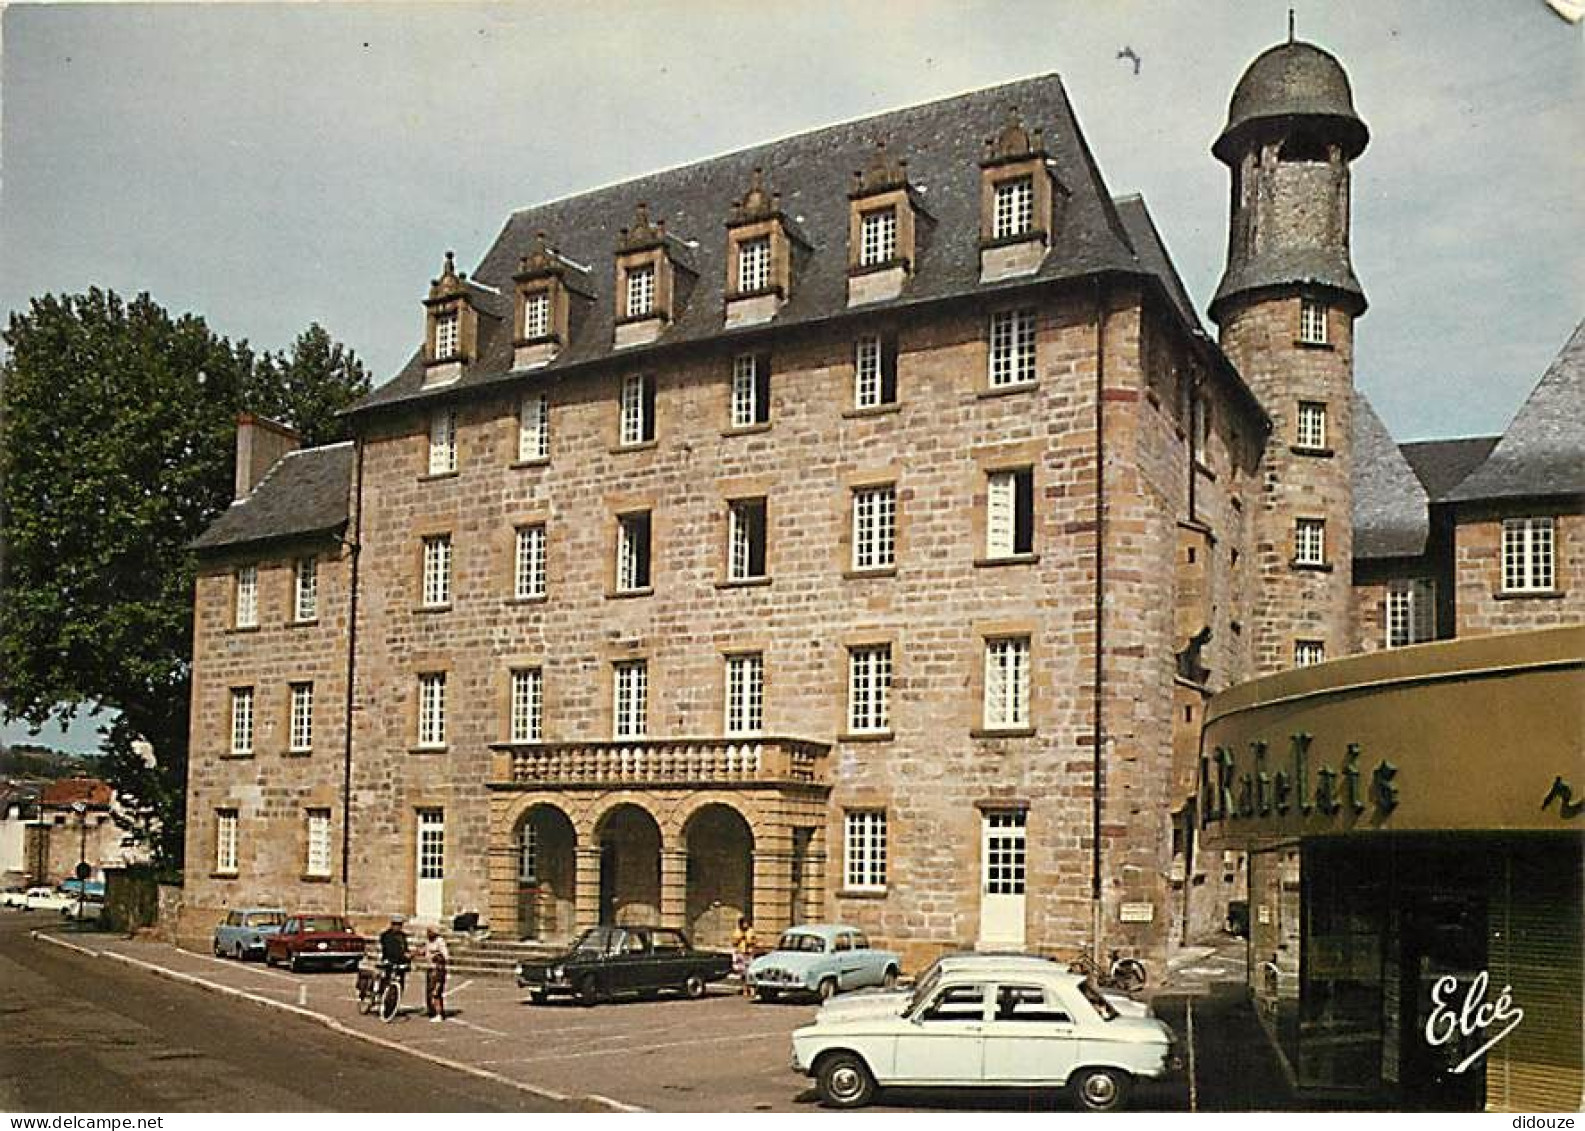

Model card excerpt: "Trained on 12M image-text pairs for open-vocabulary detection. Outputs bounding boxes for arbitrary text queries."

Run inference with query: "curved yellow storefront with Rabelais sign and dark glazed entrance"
[1200,627,1585,1112]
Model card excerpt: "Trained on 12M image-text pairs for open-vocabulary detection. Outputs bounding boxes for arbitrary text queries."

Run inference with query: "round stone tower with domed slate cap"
[1211,40,1369,673]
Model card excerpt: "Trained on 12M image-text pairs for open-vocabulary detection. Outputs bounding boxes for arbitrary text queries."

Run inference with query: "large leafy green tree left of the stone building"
[0,288,369,868]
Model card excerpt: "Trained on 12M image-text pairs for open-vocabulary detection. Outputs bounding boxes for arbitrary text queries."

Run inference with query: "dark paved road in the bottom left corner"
[0,909,569,1112]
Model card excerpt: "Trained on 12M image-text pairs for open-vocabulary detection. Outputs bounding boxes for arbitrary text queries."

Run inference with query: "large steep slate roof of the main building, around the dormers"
[352,74,1258,413]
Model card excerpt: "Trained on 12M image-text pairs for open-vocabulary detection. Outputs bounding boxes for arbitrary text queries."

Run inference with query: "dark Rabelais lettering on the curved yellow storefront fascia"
[1200,733,1398,825]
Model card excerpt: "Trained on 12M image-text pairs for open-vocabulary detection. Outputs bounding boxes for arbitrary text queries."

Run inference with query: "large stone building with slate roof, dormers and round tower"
[185,43,1580,962]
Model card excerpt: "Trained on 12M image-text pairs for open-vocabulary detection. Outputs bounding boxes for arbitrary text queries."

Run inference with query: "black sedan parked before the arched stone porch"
[517,927,732,1006]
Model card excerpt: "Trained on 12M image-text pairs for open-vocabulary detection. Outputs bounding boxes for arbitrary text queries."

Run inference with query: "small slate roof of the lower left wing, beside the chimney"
[190,440,353,551]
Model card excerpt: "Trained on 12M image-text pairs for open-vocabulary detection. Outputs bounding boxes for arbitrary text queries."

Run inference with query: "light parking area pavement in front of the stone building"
[37,935,1187,1112]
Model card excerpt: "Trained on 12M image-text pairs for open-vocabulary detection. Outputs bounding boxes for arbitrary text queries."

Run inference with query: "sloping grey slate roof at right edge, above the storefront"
[1446,322,1585,502]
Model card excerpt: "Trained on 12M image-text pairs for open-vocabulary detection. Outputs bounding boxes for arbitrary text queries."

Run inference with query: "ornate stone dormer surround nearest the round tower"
[980,106,1068,282]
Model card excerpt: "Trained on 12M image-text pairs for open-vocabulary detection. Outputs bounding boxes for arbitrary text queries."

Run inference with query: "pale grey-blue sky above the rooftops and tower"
[0,0,1585,439]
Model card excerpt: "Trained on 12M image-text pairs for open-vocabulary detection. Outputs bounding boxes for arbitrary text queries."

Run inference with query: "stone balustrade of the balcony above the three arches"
[495,737,829,786]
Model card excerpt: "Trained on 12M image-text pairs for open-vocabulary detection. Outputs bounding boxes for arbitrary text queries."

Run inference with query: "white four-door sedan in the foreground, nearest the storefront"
[793,957,1178,1112]
